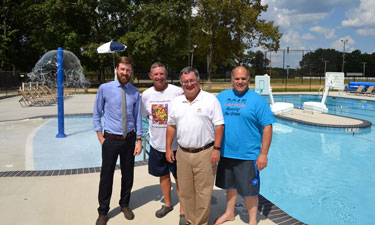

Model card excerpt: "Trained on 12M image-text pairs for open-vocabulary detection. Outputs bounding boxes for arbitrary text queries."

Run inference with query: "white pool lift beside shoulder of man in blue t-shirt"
[255,74,294,115]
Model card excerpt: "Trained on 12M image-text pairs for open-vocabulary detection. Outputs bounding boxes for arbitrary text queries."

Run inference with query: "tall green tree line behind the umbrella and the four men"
[0,0,282,82]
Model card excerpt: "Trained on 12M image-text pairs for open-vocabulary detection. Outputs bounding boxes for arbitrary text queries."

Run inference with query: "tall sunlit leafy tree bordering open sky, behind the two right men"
[195,0,281,80]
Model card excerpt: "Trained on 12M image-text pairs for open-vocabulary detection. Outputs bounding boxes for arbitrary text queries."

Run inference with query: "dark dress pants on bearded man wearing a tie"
[98,134,136,215]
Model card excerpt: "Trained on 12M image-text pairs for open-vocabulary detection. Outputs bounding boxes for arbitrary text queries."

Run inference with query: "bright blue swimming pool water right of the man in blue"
[261,95,375,225]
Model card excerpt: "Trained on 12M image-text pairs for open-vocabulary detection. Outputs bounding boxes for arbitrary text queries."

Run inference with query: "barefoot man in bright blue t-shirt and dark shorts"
[215,66,276,225]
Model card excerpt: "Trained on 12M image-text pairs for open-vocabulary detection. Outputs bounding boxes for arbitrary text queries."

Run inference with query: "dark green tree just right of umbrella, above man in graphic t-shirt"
[120,0,188,71]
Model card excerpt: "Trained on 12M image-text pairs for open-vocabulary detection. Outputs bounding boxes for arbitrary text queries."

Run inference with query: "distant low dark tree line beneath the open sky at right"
[262,48,375,78]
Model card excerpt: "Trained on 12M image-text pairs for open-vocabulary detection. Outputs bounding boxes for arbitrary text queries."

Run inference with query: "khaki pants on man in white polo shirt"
[176,147,216,225]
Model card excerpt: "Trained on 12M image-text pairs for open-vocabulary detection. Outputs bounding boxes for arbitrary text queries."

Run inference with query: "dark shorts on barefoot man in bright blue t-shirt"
[215,157,260,197]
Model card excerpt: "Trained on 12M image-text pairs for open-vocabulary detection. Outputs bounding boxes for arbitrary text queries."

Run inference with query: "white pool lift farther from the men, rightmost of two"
[303,72,345,114]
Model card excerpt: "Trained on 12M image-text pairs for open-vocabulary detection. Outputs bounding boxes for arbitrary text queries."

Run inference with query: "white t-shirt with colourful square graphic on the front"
[141,84,183,152]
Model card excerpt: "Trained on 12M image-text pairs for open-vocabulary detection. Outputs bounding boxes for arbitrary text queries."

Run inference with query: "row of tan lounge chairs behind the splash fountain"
[18,86,57,107]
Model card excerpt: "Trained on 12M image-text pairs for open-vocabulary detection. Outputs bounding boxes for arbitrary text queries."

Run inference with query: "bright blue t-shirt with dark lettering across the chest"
[216,89,276,160]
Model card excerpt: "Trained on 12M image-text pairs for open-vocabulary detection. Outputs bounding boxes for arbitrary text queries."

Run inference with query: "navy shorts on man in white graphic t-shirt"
[148,145,177,179]
